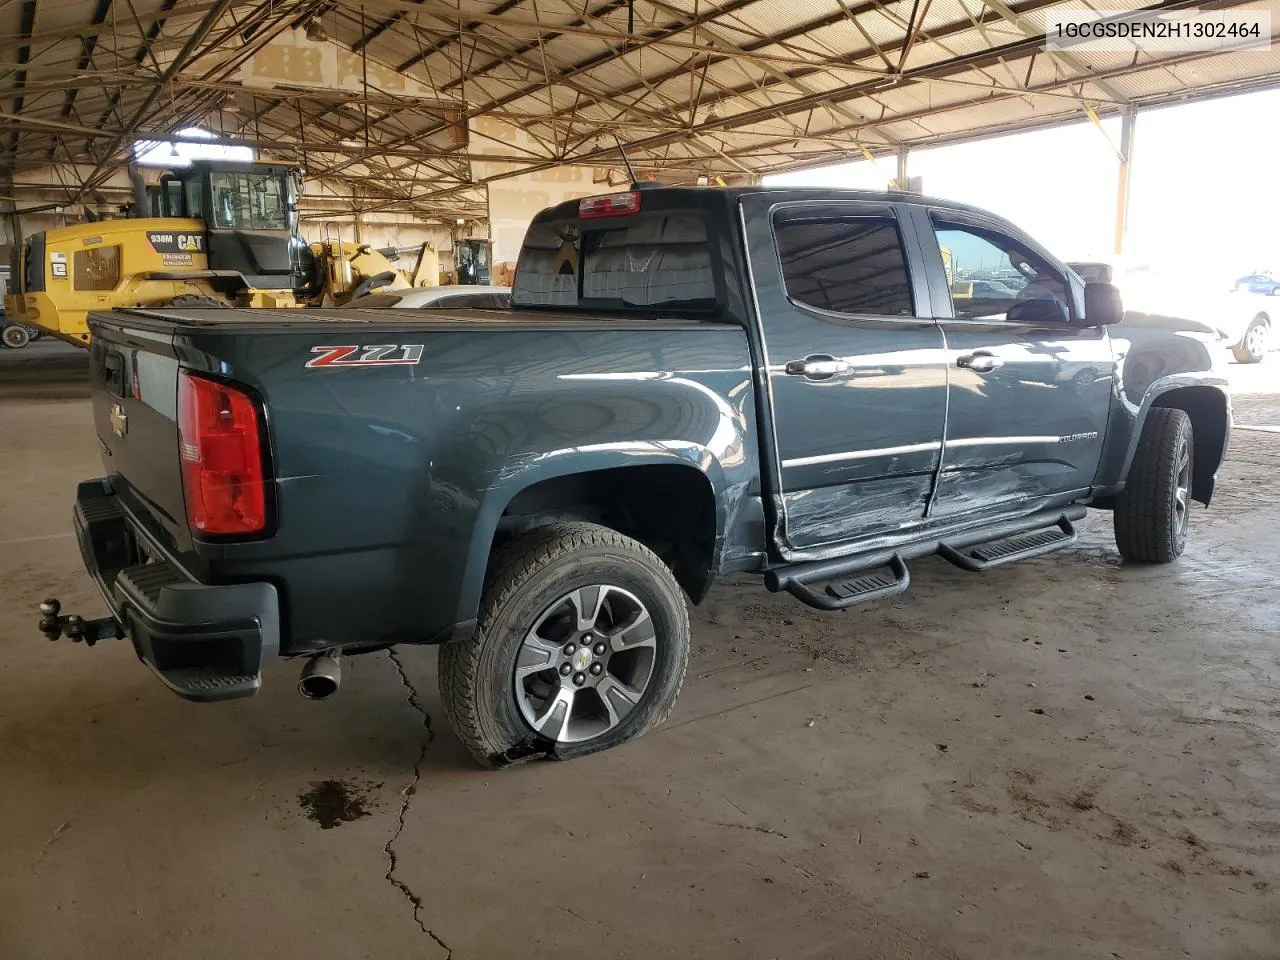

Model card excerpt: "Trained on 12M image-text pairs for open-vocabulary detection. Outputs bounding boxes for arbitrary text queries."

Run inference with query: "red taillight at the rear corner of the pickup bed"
[178,372,266,536]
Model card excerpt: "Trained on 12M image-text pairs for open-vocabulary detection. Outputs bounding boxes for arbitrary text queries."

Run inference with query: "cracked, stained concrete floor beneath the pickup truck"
[0,344,1280,960]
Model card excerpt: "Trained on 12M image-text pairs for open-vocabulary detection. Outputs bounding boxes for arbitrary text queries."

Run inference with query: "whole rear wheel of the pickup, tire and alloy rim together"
[439,524,690,767]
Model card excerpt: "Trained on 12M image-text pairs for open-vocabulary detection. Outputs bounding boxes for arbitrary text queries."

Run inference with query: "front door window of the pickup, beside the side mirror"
[933,223,1069,320]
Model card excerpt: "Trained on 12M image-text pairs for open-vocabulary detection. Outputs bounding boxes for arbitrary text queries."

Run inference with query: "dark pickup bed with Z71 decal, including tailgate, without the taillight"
[91,308,760,653]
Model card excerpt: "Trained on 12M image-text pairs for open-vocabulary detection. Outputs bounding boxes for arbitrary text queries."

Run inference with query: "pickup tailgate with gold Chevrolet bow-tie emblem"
[90,314,191,550]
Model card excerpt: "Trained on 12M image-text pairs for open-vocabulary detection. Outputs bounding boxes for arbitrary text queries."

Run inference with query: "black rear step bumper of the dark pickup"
[76,479,280,700]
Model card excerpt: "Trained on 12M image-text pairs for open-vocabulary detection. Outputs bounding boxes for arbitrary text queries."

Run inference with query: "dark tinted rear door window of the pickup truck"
[773,216,914,316]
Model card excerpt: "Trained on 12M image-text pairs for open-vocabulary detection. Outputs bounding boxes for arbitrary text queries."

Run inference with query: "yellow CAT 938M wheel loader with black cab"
[5,160,436,346]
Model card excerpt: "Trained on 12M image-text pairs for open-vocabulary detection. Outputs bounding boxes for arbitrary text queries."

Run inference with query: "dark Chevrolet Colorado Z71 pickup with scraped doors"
[41,188,1231,765]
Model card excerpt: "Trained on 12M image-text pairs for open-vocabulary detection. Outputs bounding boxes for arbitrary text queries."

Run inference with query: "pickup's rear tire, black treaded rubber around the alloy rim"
[439,522,690,768]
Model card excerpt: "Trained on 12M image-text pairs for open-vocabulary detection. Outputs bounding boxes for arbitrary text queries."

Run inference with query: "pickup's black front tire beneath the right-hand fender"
[1112,407,1196,563]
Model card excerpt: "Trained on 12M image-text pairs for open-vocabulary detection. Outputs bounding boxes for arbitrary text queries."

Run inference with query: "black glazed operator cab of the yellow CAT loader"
[157,160,315,291]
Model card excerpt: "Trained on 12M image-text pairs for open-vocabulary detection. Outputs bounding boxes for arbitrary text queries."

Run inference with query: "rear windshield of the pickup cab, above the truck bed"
[512,212,717,310]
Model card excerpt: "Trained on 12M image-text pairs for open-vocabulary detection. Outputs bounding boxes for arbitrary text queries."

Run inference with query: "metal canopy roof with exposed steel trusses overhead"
[0,0,1280,216]
